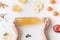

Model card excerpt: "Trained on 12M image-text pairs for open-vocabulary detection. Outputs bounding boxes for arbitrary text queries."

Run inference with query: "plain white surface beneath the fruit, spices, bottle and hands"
[0,0,60,40]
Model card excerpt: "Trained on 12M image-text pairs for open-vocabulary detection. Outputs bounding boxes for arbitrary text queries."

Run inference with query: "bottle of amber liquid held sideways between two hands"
[15,17,43,26]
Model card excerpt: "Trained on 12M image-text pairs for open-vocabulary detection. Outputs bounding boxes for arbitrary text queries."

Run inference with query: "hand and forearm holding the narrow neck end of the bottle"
[42,17,50,40]
